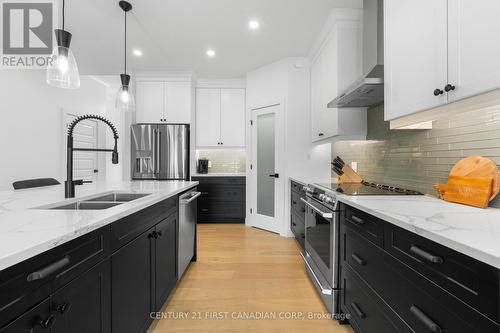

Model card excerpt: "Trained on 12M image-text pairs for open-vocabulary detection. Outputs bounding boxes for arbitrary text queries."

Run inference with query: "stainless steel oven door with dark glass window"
[305,196,338,289]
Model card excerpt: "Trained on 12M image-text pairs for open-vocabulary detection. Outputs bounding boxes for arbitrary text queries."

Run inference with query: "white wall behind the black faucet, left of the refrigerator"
[0,70,124,190]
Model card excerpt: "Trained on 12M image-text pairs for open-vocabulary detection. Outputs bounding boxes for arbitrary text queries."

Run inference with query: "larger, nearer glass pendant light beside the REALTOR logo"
[46,0,80,89]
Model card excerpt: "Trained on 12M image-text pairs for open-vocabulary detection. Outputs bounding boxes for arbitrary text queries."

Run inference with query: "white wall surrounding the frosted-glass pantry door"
[247,58,331,236]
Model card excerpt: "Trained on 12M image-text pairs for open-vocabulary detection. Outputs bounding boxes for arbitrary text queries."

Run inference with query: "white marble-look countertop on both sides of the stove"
[290,177,500,269]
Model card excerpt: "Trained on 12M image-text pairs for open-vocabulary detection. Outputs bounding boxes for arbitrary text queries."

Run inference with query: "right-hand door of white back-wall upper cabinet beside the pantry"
[220,89,245,147]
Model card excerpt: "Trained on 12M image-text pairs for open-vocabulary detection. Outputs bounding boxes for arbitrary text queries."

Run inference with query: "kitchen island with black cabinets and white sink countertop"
[0,181,198,333]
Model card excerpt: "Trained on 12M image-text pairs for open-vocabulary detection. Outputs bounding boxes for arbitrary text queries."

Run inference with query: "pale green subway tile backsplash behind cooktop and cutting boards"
[332,105,500,208]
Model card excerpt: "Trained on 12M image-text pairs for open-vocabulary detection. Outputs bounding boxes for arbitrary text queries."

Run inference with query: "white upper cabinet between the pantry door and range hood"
[310,15,366,142]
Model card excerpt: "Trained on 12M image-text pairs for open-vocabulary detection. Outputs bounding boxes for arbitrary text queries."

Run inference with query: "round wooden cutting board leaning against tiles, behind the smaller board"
[449,156,500,201]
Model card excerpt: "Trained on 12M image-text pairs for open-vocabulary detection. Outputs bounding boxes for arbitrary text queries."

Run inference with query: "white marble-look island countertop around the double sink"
[0,181,198,270]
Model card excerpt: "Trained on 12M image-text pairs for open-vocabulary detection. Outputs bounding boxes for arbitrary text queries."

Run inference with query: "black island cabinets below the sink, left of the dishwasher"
[0,197,184,333]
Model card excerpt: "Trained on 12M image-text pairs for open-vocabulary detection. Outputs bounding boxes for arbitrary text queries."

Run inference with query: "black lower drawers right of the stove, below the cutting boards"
[340,204,500,333]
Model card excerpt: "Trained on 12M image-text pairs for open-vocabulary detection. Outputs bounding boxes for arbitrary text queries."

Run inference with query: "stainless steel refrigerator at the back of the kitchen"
[131,124,189,180]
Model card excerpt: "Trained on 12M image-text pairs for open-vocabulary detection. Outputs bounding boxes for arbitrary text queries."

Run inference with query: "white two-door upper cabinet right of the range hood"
[384,0,500,124]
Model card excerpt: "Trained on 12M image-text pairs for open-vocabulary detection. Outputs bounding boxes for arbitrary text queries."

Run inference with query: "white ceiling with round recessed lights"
[66,0,362,78]
